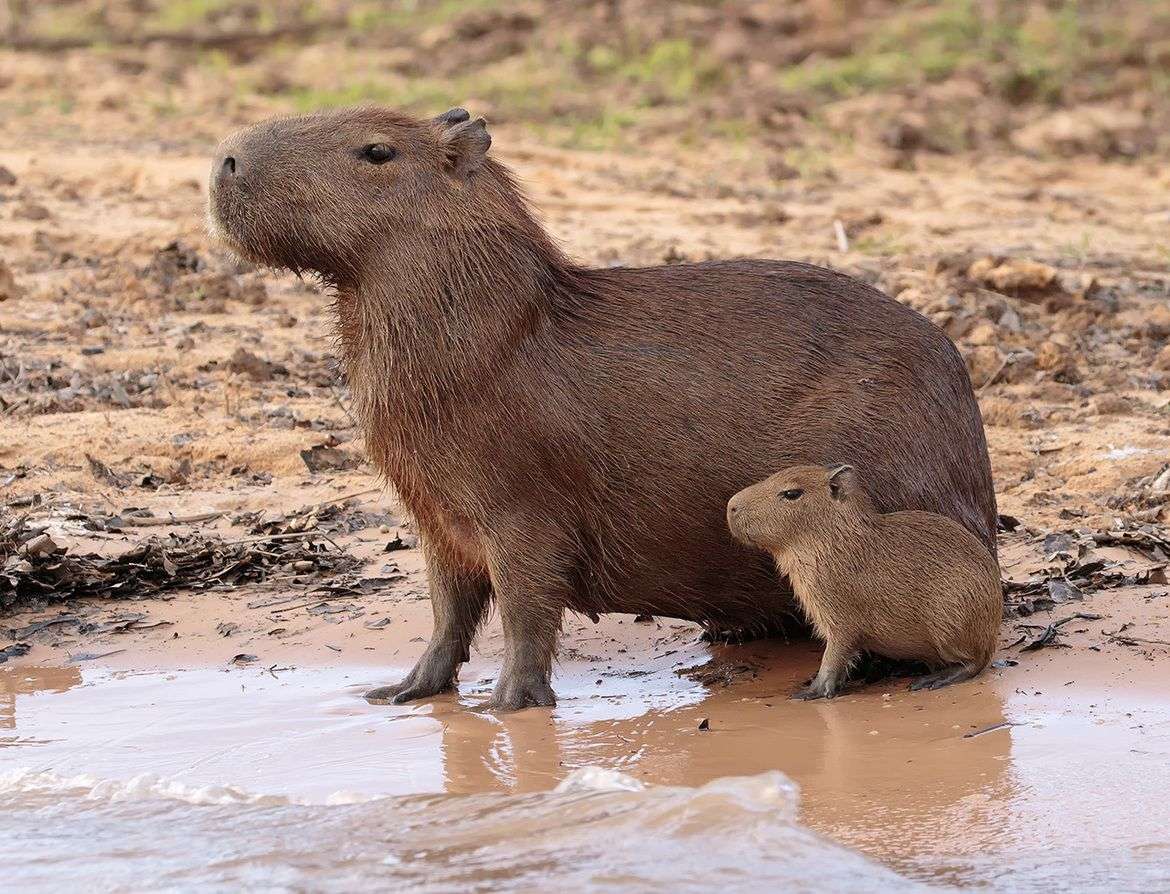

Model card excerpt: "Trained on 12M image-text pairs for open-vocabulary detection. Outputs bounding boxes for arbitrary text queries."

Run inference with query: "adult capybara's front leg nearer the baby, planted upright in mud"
[487,552,567,711]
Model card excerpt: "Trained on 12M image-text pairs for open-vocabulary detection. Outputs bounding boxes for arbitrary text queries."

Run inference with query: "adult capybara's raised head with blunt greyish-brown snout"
[209,108,515,281]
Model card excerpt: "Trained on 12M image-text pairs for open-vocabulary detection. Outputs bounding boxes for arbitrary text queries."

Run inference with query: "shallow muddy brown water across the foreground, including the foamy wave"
[0,613,1170,892]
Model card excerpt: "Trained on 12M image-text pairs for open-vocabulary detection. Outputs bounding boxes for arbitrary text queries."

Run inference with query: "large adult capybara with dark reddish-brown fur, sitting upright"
[211,108,996,709]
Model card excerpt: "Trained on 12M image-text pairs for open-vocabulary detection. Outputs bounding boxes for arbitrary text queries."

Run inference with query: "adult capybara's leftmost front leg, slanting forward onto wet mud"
[365,545,491,704]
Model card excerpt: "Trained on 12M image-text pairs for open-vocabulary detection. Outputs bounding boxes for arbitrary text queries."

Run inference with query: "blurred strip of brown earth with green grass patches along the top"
[0,0,1170,156]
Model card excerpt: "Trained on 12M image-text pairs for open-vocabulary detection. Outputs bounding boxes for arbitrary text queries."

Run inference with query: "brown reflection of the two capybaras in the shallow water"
[431,644,1012,875]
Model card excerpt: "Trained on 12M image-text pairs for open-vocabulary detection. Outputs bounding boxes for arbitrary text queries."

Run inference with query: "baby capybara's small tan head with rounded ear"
[728,466,870,552]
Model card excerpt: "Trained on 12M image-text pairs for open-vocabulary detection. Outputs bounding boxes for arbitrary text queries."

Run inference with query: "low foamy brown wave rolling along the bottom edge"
[0,766,916,892]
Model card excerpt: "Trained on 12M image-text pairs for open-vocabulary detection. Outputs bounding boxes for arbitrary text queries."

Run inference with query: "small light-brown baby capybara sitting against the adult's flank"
[728,466,1004,699]
